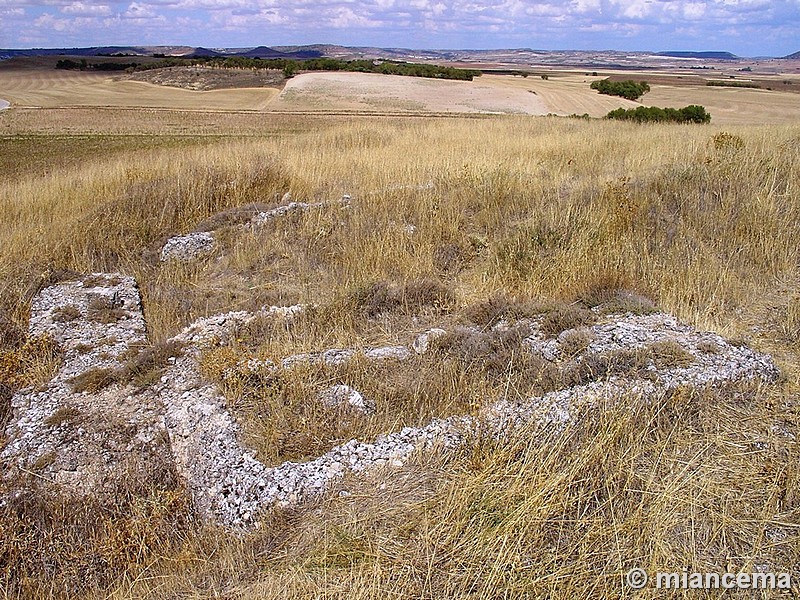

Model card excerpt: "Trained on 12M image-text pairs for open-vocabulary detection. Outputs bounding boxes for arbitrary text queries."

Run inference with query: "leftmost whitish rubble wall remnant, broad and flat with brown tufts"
[0,273,173,495]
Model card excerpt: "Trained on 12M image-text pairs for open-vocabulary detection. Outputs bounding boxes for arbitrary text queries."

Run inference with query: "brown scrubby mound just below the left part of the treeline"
[127,66,285,91]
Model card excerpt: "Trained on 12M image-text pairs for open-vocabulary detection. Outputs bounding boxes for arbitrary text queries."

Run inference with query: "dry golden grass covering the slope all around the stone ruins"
[0,111,800,598]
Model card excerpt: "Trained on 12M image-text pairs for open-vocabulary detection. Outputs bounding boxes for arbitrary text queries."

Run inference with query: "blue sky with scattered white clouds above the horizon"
[0,0,800,56]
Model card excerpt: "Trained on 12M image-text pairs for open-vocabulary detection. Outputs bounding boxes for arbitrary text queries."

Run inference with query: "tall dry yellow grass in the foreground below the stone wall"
[40,388,800,598]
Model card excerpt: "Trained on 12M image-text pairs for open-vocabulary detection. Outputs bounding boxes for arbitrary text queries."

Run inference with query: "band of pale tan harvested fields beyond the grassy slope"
[0,64,800,125]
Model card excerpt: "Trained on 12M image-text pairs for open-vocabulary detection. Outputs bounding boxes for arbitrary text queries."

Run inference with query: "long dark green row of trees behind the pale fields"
[56,56,481,81]
